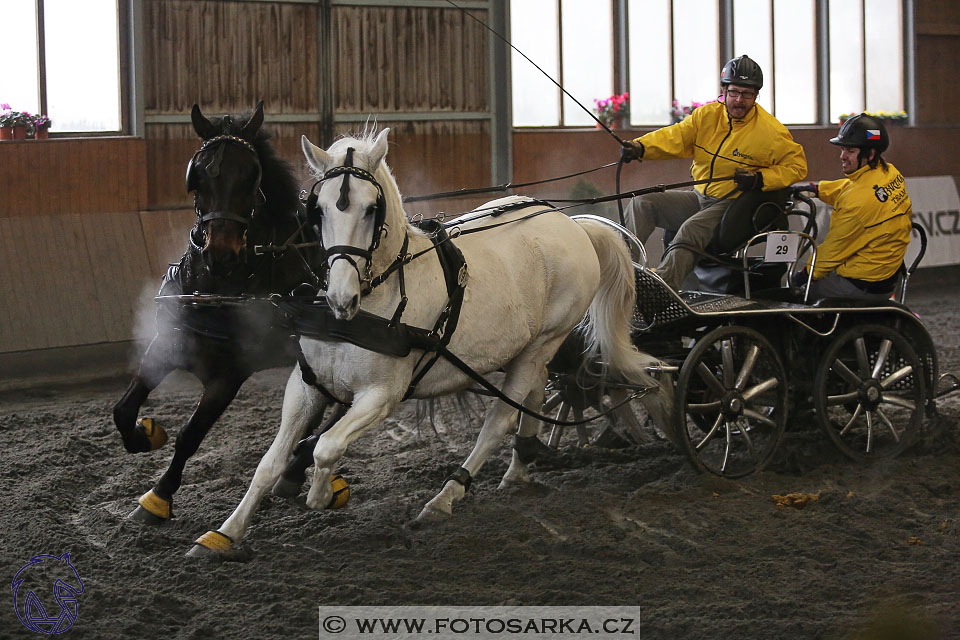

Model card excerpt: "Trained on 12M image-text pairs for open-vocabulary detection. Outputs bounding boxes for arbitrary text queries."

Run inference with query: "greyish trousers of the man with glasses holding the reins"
[624,191,736,291]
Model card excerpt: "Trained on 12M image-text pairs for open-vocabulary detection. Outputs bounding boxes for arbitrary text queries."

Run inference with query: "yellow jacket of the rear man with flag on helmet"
[813,163,913,282]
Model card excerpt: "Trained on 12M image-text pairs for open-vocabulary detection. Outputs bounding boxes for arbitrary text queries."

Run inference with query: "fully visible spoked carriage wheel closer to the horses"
[675,327,787,478]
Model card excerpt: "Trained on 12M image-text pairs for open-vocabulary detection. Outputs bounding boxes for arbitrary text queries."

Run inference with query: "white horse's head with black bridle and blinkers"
[301,129,390,320]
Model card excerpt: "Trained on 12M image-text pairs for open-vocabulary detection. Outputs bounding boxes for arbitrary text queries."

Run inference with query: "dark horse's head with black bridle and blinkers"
[187,102,264,275]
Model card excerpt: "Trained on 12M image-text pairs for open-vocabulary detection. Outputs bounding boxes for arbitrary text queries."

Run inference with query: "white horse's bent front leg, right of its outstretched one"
[307,392,398,510]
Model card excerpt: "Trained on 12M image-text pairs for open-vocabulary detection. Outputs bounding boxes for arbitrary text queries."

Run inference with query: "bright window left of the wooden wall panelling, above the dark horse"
[0,0,122,133]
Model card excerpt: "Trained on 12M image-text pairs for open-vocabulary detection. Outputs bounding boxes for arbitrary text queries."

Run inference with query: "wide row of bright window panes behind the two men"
[510,0,909,126]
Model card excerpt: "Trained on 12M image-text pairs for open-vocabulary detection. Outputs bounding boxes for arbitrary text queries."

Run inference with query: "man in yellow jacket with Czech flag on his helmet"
[794,114,913,300]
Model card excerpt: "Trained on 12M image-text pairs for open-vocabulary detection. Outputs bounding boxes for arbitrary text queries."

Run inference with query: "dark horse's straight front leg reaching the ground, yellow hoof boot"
[130,371,247,524]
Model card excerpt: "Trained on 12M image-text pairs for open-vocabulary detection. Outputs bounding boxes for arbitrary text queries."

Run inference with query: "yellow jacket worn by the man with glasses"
[636,102,807,198]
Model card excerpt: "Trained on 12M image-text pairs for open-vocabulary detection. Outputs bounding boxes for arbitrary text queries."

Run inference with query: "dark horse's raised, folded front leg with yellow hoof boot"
[113,336,177,453]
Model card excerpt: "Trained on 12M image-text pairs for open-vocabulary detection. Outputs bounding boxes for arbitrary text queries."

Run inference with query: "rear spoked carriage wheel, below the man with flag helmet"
[813,325,926,461]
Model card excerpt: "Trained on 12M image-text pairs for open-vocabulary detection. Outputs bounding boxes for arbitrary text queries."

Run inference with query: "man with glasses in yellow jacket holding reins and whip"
[621,56,807,290]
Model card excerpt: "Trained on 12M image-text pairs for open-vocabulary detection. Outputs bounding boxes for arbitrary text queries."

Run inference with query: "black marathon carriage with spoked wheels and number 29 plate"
[545,194,960,478]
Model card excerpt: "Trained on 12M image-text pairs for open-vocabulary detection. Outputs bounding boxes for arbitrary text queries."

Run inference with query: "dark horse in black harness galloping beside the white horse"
[113,102,338,523]
